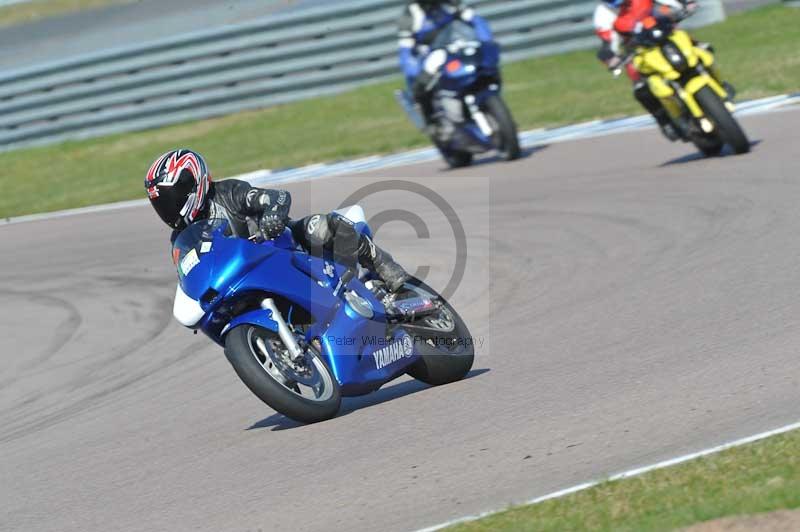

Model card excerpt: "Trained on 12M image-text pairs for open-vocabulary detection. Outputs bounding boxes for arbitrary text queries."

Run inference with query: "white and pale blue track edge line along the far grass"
[6,94,800,227]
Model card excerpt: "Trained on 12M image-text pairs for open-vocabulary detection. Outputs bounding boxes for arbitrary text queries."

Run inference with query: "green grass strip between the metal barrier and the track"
[0,6,800,217]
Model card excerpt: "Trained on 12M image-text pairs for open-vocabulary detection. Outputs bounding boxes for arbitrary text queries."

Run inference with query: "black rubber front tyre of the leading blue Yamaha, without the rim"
[225,324,342,423]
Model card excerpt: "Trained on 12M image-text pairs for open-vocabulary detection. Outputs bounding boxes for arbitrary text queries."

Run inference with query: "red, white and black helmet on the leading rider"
[144,148,211,229]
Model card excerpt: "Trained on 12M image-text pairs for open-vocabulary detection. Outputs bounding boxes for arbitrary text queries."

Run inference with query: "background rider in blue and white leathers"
[398,0,493,125]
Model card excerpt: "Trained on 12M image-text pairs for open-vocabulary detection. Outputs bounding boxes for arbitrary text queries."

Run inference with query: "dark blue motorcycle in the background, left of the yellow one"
[397,21,520,168]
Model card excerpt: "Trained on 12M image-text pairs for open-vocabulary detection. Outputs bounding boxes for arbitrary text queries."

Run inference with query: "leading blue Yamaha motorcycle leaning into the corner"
[173,206,474,423]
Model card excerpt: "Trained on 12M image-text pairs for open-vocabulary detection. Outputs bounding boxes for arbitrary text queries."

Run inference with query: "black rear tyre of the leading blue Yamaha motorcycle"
[406,278,475,386]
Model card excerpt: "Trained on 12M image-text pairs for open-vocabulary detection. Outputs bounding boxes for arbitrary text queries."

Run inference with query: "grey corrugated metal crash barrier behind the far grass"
[0,0,724,150]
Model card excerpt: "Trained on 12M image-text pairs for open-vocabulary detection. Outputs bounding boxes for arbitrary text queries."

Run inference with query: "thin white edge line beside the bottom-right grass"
[417,421,800,532]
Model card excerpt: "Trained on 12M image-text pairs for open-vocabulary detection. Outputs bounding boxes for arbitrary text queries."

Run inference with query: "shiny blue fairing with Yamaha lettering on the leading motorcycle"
[174,220,418,395]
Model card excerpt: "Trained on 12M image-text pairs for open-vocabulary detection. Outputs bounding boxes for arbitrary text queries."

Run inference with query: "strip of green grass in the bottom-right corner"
[448,431,800,532]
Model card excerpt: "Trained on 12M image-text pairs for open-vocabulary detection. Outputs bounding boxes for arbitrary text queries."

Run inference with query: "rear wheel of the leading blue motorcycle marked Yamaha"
[404,278,475,386]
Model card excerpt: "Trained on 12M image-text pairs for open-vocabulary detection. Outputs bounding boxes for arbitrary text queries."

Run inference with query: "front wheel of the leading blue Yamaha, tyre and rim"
[225,324,342,423]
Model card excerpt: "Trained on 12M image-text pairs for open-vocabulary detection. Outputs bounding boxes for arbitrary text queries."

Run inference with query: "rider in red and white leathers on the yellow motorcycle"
[594,0,678,140]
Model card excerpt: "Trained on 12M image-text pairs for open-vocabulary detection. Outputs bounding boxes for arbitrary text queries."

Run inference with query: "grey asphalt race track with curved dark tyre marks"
[0,106,800,531]
